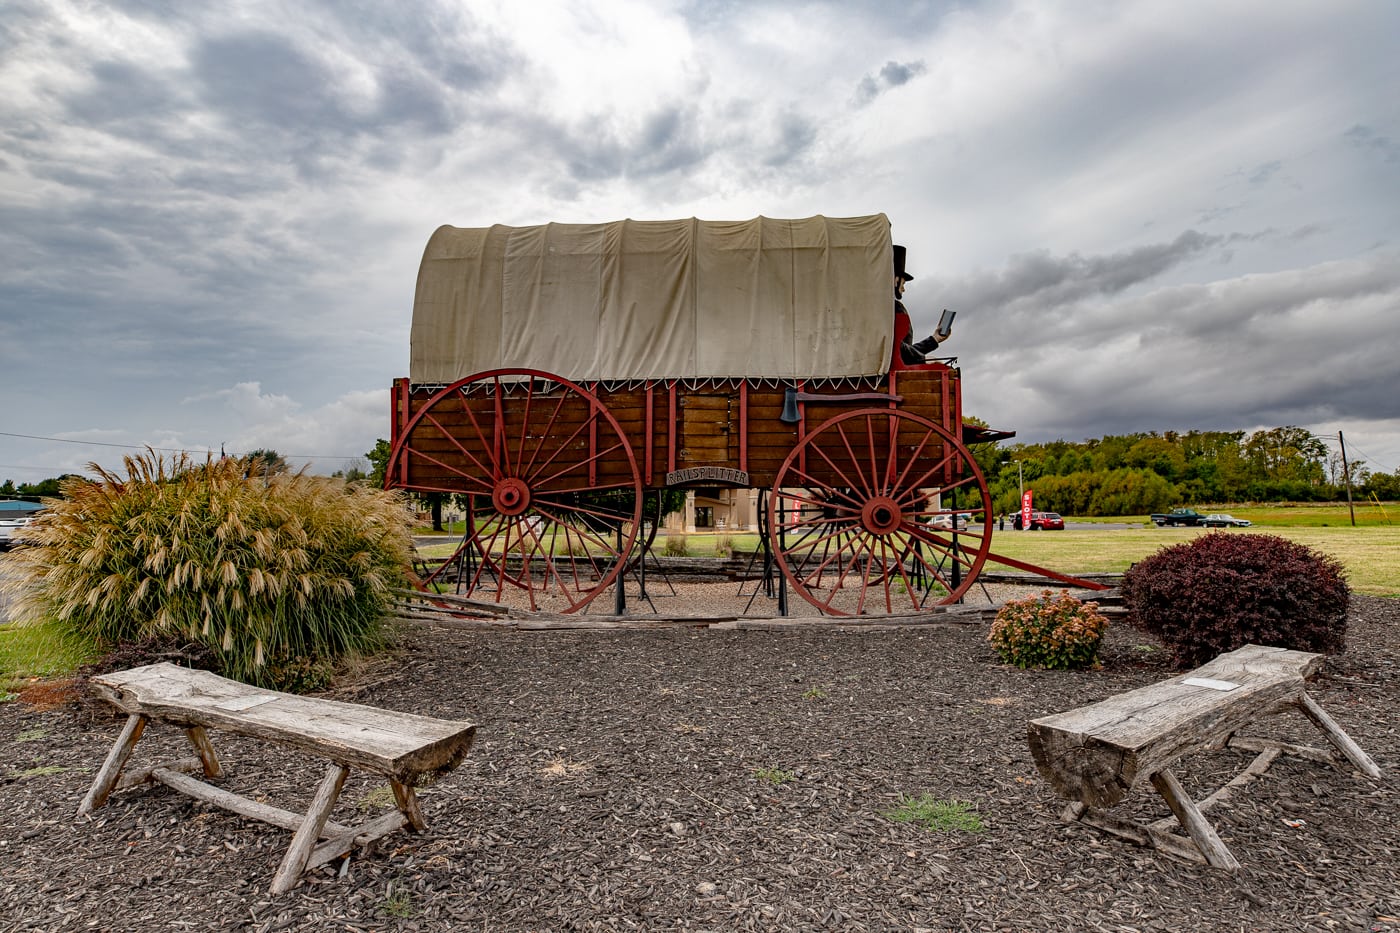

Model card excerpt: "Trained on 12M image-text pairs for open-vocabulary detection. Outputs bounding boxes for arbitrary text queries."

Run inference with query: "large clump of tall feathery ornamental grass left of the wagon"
[2,452,410,689]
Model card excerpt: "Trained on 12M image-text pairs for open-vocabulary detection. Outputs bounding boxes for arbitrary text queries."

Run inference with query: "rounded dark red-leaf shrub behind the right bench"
[1123,532,1350,668]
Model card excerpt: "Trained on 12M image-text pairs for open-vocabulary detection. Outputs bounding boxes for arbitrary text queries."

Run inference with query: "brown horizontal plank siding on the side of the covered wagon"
[392,364,962,493]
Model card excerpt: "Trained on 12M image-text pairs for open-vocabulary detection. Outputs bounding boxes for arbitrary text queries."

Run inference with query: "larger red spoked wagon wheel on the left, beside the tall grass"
[388,370,641,612]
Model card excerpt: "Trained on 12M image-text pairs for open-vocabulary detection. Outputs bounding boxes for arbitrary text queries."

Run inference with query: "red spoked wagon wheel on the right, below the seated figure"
[769,409,991,615]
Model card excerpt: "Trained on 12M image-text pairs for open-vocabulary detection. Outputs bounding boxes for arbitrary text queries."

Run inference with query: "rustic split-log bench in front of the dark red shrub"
[1029,644,1380,871]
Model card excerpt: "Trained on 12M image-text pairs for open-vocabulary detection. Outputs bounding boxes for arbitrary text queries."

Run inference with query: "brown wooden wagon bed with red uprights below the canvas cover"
[392,364,962,493]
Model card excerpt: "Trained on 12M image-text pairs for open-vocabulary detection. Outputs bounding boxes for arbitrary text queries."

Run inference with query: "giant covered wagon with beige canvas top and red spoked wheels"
[386,214,1013,615]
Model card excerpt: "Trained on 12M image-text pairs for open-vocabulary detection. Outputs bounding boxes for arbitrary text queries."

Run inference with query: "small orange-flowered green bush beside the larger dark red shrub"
[987,590,1109,671]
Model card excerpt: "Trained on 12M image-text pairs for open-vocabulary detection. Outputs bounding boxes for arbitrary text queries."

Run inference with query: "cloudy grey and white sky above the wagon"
[0,0,1400,482]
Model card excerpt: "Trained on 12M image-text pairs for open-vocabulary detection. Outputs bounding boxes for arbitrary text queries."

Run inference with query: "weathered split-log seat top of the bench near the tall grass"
[91,663,476,780]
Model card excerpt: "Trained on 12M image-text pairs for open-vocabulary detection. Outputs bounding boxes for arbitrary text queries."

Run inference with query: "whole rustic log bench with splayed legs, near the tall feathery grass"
[78,663,476,894]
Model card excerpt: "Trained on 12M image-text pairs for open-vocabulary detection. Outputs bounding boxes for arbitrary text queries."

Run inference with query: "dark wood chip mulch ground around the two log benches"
[0,597,1400,933]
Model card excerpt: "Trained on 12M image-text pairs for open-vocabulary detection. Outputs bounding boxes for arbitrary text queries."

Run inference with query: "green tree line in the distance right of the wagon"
[973,426,1400,516]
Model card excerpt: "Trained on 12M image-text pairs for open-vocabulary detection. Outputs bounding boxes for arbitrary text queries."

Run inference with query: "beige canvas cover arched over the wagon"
[409,214,893,384]
